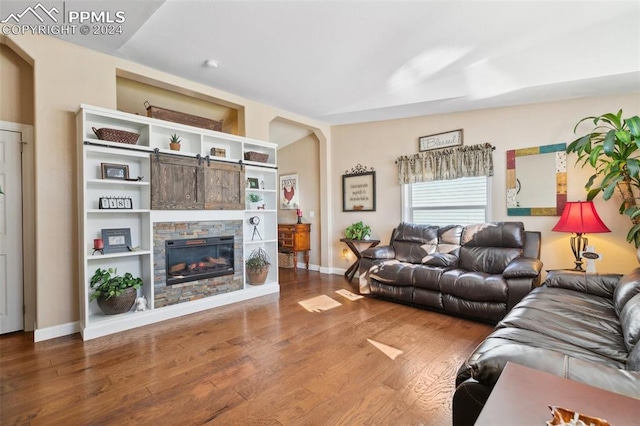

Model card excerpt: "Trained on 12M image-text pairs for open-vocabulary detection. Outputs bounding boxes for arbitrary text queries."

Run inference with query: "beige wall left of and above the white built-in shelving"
[5,35,329,329]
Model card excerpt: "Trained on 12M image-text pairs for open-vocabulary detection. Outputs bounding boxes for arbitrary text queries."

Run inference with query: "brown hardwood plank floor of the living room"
[0,269,492,425]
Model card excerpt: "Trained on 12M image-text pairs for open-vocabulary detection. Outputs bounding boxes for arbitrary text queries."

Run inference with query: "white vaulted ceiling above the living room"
[51,0,640,131]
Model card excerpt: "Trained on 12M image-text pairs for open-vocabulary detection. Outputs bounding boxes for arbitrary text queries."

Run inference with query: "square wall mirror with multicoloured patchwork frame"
[507,143,567,216]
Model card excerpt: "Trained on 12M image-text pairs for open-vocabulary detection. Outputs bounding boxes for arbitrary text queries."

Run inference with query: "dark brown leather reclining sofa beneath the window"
[359,222,542,323]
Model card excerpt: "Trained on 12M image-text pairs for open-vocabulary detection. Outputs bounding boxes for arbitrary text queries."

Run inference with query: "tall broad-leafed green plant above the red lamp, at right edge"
[567,110,640,248]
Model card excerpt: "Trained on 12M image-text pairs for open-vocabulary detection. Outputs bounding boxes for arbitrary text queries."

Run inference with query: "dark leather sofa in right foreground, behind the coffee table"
[453,269,640,426]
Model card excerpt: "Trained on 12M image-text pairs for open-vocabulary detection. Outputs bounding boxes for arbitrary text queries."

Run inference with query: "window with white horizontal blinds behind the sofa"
[403,176,488,226]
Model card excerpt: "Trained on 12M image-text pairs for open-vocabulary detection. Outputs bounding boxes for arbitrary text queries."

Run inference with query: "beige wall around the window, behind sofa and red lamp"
[331,93,640,272]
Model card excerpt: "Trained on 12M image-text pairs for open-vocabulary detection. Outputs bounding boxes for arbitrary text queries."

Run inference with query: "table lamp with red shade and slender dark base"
[551,201,611,271]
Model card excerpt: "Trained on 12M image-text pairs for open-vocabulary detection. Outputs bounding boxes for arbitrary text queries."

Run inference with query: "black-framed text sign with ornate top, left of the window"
[342,164,376,212]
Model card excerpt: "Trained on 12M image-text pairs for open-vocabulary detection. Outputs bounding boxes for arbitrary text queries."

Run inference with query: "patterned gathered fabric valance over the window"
[396,143,494,184]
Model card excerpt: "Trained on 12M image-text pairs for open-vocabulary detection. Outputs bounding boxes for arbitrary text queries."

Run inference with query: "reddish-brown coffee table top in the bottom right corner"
[475,362,640,426]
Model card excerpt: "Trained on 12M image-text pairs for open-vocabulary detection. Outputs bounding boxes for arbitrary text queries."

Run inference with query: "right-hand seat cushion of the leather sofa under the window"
[440,269,507,303]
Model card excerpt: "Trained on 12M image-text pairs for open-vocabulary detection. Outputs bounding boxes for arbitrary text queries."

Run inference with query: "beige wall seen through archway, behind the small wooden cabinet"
[278,134,323,265]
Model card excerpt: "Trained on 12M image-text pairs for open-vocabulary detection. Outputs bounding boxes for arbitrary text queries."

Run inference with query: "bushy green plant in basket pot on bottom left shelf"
[89,268,143,315]
